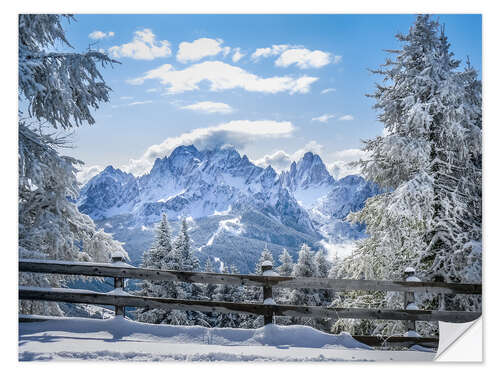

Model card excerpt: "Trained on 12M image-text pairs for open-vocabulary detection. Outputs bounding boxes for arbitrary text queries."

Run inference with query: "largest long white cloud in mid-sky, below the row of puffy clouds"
[128,61,318,94]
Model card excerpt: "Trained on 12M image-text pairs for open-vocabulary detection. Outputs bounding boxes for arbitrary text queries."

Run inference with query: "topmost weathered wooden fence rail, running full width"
[19,260,482,294]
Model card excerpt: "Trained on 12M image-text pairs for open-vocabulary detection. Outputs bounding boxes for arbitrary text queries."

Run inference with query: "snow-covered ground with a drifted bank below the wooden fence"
[19,317,435,361]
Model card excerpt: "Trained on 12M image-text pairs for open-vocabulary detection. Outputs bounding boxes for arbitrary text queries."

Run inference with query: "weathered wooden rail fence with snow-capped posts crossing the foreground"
[19,258,482,346]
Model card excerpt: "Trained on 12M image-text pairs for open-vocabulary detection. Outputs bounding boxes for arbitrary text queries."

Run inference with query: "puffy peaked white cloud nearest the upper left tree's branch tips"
[108,29,172,60]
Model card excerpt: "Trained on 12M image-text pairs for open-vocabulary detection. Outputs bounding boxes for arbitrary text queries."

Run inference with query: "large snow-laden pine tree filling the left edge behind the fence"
[18,14,127,315]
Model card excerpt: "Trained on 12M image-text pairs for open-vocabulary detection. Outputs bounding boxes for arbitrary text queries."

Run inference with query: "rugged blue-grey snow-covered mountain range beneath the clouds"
[78,146,379,272]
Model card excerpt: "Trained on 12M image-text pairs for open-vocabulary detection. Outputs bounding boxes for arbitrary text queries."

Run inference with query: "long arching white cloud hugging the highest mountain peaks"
[121,120,294,176]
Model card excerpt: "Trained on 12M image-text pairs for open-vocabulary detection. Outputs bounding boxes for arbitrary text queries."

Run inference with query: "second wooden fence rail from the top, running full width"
[19,287,481,323]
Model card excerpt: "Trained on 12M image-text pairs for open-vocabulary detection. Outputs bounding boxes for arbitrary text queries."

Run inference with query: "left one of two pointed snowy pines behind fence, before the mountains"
[136,214,179,324]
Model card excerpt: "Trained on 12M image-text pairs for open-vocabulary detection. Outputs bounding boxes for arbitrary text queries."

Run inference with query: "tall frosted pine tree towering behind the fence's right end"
[342,15,482,334]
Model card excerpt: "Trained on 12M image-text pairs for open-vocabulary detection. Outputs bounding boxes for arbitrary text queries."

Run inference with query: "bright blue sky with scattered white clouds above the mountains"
[60,15,482,184]
